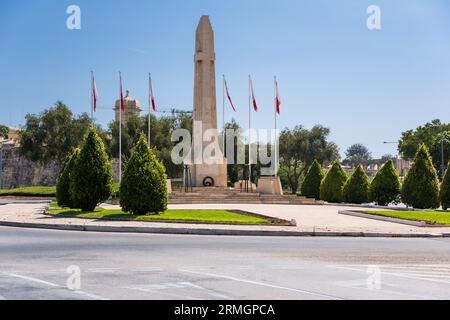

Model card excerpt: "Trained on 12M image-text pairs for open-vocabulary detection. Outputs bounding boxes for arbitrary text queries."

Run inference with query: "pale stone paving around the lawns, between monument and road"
[0,203,450,235]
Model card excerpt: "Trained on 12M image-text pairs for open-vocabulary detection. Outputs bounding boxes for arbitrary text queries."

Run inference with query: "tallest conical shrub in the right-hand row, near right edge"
[402,144,439,209]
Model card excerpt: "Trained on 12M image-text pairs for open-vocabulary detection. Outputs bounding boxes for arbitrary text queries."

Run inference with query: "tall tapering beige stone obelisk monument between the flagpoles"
[191,16,227,187]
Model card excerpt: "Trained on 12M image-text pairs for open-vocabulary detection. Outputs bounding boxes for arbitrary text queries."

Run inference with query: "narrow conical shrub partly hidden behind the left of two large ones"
[56,148,80,208]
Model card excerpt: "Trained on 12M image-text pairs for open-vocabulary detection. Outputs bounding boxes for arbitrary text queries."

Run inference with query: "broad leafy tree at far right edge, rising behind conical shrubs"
[398,119,450,178]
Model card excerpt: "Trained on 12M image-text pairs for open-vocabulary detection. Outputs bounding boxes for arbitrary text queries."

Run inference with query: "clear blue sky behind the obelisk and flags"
[0,0,450,157]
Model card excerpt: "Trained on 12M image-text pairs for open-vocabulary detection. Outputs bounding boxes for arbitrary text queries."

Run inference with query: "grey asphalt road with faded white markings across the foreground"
[0,227,450,299]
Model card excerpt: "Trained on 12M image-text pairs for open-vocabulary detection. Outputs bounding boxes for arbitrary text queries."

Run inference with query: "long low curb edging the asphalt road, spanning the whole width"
[0,221,444,238]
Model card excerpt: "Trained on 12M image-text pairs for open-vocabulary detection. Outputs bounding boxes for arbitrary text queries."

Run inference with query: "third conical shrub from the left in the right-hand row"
[342,165,369,204]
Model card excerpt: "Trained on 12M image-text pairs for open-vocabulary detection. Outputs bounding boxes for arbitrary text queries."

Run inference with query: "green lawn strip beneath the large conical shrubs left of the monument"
[48,208,271,224]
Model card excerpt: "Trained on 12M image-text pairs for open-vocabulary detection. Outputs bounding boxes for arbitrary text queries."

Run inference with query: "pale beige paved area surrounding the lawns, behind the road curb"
[0,203,450,236]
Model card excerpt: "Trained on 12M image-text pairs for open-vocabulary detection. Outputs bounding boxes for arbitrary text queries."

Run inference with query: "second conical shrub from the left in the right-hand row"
[320,160,347,202]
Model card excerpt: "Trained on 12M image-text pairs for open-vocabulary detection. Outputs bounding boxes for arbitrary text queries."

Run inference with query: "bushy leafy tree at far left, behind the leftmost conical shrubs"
[19,101,106,166]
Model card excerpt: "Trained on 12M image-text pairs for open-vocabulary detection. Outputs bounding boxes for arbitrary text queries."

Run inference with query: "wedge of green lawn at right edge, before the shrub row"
[366,210,450,225]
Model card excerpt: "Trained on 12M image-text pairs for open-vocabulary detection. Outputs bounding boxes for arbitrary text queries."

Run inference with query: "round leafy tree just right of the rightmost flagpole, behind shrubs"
[278,125,339,194]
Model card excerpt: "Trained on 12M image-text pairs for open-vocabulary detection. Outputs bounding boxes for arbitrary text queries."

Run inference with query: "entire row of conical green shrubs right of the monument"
[301,145,450,210]
